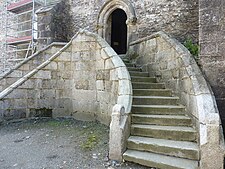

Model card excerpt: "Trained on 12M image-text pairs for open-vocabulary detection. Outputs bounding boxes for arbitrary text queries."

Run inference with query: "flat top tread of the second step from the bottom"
[128,136,198,151]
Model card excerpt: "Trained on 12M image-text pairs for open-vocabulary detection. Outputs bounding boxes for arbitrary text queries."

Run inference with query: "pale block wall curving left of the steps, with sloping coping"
[0,31,132,125]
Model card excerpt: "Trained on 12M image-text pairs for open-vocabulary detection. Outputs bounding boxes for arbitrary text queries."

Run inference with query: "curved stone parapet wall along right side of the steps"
[128,32,224,168]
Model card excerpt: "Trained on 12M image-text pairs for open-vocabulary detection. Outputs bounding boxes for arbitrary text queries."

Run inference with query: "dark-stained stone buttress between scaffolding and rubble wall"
[36,1,72,49]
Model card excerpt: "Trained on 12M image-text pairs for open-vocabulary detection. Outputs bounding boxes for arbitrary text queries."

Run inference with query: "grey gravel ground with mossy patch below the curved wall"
[0,118,151,169]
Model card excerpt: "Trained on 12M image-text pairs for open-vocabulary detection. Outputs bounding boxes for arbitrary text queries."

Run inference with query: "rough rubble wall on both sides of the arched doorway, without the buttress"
[67,0,198,41]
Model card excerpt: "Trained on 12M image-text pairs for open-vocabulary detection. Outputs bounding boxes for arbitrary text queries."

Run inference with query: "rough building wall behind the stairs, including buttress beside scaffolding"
[0,0,198,73]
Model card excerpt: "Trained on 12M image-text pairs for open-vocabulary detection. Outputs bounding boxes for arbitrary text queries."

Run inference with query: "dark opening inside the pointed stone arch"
[111,9,127,54]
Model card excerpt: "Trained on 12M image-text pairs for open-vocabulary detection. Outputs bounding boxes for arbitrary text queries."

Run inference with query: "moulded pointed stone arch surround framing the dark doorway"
[97,0,137,48]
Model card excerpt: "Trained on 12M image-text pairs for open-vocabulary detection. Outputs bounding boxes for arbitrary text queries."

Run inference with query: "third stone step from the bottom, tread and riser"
[131,124,197,142]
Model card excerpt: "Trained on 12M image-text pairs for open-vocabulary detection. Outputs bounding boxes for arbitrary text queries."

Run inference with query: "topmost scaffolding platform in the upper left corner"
[7,0,42,14]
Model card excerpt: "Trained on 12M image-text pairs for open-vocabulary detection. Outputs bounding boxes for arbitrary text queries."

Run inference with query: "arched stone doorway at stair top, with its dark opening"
[96,0,137,54]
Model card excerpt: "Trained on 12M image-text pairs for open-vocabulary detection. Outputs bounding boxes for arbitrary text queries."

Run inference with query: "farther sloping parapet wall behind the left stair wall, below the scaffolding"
[0,42,66,91]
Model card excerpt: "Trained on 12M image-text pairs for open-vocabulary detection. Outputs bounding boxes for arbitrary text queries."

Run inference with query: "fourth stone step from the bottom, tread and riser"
[131,114,192,126]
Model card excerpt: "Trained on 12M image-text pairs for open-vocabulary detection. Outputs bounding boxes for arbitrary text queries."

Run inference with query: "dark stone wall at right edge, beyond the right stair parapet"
[199,0,225,132]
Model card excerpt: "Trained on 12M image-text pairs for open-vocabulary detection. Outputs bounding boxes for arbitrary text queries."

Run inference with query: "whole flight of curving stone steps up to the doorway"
[123,59,199,169]
